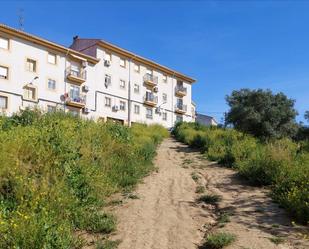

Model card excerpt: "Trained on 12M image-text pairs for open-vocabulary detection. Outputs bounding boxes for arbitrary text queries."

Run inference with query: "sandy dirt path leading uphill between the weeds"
[112,139,309,249]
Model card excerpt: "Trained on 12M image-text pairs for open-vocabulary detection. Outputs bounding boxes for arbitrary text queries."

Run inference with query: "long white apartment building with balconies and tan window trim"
[0,24,195,127]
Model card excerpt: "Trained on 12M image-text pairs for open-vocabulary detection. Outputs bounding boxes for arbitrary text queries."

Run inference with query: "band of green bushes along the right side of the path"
[173,123,309,224]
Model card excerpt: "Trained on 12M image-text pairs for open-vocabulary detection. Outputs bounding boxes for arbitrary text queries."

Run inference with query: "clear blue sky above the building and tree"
[0,0,309,121]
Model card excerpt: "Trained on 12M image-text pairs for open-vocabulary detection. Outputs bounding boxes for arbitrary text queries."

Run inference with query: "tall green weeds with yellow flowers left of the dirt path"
[0,110,167,249]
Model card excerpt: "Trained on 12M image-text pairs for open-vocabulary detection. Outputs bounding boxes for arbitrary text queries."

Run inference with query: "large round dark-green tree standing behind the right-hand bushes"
[226,89,297,139]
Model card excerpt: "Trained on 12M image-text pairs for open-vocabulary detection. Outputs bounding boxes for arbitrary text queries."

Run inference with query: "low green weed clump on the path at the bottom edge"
[201,232,236,249]
